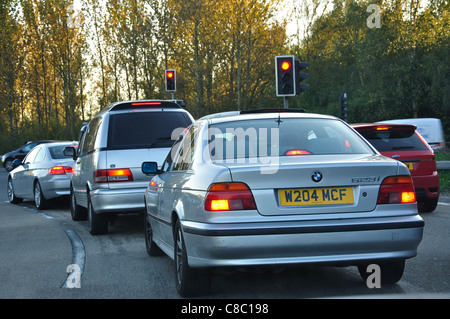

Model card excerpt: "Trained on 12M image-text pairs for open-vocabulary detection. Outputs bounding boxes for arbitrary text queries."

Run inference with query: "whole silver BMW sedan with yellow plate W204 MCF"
[142,109,424,296]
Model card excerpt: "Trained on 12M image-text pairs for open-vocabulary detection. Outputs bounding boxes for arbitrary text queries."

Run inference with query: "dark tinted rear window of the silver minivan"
[108,112,191,149]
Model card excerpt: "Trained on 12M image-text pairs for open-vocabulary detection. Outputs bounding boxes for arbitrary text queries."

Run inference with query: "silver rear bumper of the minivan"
[90,188,146,214]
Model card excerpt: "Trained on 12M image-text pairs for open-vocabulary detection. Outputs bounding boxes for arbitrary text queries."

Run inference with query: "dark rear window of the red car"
[360,129,428,152]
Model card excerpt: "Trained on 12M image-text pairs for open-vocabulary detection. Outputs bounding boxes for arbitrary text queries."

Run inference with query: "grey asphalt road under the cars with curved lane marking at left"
[0,168,450,304]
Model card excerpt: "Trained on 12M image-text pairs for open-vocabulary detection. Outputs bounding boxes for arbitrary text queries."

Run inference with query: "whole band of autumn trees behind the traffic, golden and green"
[0,0,450,153]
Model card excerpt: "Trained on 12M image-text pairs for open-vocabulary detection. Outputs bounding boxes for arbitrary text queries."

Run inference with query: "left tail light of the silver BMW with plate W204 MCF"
[205,183,256,211]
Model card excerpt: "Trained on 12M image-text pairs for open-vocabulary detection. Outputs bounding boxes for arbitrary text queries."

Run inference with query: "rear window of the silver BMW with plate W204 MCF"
[209,118,373,160]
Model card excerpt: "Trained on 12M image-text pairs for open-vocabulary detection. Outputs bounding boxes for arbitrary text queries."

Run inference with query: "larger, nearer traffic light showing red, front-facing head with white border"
[275,55,296,96]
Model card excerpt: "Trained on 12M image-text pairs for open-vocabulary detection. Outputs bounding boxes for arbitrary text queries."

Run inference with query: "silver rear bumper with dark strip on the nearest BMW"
[181,215,424,267]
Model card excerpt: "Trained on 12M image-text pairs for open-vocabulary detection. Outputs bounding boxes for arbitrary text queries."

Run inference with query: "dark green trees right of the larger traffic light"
[293,0,450,134]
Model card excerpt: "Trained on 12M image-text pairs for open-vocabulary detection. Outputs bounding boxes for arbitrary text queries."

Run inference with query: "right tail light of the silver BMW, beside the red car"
[377,176,416,204]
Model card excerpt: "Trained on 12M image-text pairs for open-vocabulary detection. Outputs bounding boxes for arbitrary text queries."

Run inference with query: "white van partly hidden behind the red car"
[377,118,445,151]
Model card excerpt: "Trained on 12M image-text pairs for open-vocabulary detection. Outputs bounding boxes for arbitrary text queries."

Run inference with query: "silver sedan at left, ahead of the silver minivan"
[7,141,77,209]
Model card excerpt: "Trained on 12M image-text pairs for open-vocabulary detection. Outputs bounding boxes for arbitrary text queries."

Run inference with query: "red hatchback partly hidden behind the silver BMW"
[351,124,440,213]
